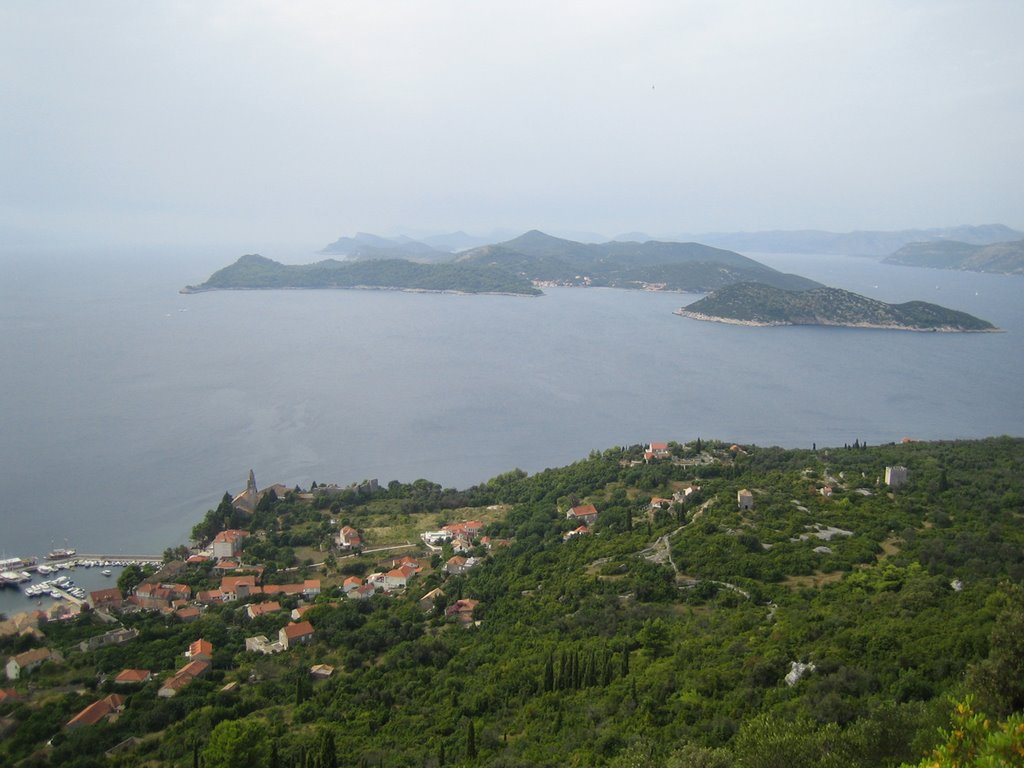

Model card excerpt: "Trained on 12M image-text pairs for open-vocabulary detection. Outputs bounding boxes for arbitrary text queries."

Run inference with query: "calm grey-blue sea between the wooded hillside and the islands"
[0,249,1024,610]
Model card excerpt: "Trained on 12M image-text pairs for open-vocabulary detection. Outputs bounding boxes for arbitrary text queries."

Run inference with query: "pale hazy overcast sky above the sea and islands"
[0,0,1024,248]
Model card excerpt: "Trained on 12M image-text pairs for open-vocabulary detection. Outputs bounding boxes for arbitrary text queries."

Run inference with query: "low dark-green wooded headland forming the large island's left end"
[184,254,541,296]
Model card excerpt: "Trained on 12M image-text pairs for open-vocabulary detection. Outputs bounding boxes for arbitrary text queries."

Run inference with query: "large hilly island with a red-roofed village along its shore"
[181,230,820,295]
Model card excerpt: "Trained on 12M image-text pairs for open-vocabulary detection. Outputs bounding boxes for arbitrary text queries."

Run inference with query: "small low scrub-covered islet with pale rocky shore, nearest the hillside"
[676,283,998,332]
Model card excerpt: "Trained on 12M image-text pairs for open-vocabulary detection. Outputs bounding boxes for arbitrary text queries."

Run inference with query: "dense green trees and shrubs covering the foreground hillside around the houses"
[0,437,1024,768]
